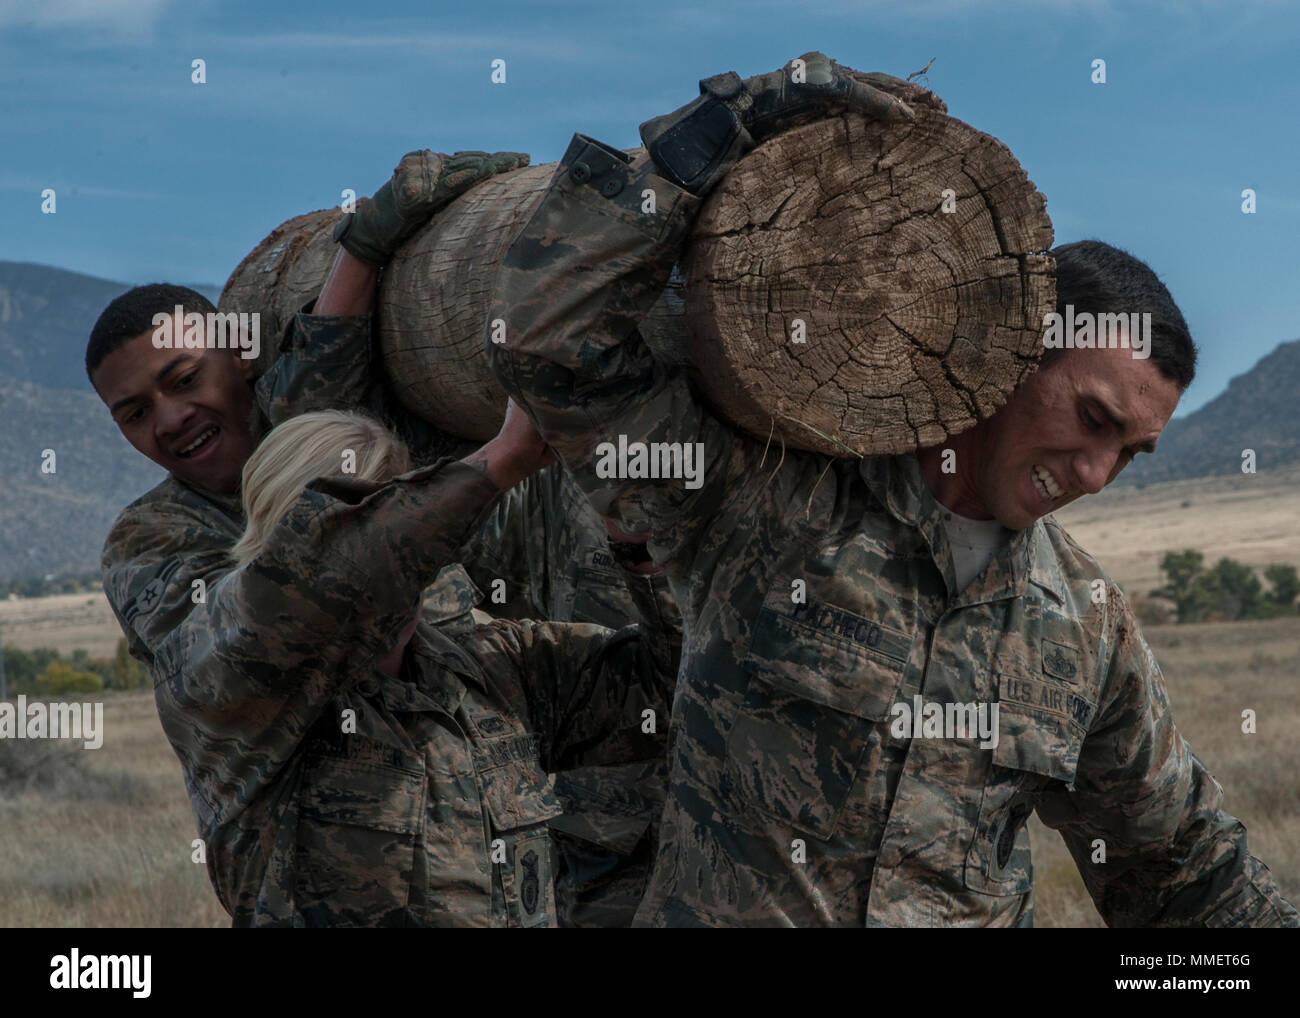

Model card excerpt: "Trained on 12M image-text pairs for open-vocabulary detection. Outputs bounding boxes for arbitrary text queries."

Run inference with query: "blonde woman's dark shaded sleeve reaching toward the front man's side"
[480,620,676,772]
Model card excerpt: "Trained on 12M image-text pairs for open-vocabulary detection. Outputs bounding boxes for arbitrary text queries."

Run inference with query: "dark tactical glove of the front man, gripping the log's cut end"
[641,52,914,195]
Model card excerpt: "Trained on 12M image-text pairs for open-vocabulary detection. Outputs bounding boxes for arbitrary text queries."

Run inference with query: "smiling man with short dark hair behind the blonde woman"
[86,151,528,666]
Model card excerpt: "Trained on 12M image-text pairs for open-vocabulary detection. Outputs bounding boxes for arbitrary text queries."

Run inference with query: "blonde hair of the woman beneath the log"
[231,410,411,566]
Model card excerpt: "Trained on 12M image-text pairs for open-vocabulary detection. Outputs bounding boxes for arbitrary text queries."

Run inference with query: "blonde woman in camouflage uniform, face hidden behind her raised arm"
[157,411,677,926]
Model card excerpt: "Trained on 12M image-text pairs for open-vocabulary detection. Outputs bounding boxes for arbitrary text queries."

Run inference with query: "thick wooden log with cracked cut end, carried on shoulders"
[221,91,1056,455]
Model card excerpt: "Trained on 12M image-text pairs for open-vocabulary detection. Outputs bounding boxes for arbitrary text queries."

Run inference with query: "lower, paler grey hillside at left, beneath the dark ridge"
[0,378,165,580]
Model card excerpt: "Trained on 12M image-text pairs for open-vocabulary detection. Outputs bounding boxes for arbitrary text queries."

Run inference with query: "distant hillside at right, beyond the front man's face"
[1115,339,1300,485]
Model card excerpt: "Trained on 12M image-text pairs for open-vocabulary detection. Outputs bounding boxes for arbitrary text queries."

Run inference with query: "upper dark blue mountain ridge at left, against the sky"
[0,261,221,393]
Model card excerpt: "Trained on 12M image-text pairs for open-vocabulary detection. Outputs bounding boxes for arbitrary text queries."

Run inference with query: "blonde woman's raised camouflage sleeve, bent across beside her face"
[153,463,497,823]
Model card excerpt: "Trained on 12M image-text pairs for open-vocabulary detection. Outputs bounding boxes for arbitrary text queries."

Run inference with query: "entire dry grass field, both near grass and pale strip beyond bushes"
[0,472,1300,927]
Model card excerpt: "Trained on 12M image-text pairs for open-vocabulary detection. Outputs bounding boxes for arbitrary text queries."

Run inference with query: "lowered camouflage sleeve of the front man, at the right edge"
[1039,586,1300,927]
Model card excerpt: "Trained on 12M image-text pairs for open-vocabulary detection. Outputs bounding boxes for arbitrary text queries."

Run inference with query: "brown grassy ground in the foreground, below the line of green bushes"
[0,608,1300,927]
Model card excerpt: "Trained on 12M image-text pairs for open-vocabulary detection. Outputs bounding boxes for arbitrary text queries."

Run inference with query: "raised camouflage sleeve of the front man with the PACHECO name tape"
[485,135,763,568]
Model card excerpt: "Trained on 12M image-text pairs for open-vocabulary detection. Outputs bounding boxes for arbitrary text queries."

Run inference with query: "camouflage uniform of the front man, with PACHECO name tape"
[485,135,1297,926]
